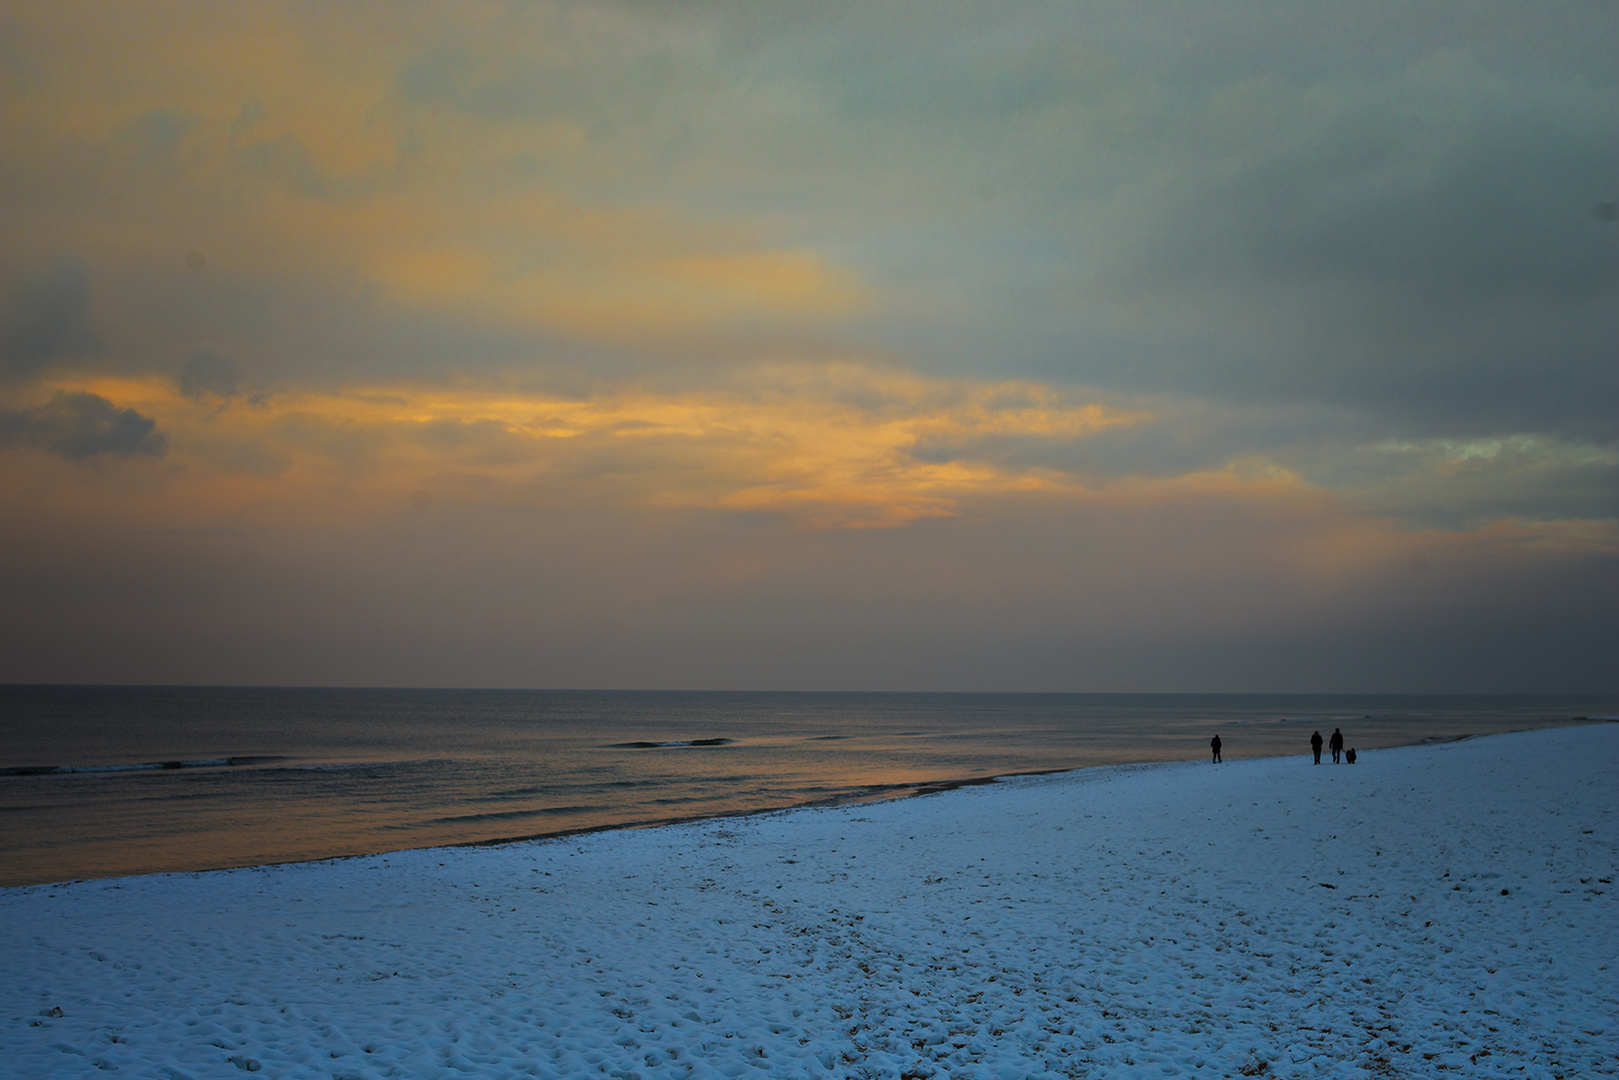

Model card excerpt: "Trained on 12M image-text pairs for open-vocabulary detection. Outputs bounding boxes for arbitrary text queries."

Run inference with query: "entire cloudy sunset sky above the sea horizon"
[0,0,1619,693]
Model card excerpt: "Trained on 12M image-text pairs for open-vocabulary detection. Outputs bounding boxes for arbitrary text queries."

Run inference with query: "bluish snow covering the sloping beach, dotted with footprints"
[0,725,1619,1078]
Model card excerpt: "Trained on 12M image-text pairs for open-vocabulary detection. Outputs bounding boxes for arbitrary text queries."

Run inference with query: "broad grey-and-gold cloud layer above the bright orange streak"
[8,3,1619,437]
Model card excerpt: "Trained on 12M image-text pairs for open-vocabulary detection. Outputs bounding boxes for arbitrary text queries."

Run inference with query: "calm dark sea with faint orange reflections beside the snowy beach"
[0,687,1619,886]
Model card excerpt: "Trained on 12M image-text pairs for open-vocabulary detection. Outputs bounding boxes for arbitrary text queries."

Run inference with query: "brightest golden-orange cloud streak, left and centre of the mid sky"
[22,364,1146,528]
